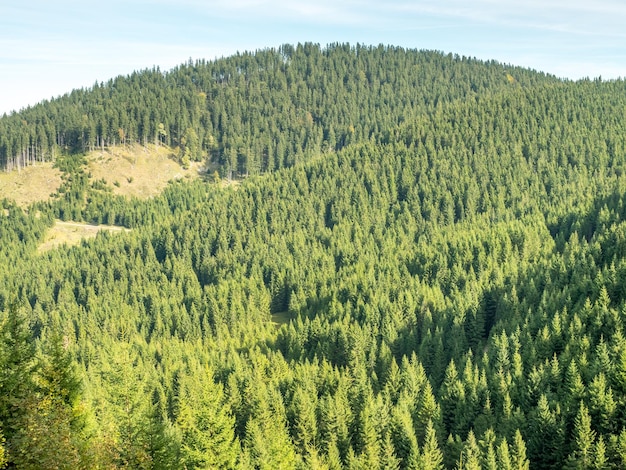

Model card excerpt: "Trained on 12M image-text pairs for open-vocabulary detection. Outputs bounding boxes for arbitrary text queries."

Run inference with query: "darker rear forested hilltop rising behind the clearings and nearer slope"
[0,44,555,175]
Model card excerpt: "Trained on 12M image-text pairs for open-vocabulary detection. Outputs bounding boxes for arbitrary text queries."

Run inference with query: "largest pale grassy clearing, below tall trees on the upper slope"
[87,145,204,199]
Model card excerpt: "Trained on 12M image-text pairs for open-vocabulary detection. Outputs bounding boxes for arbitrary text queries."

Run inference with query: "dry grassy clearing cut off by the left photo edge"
[0,162,61,208]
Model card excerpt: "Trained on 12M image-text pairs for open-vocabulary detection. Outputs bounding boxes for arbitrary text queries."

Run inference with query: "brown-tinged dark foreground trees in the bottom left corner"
[0,304,91,468]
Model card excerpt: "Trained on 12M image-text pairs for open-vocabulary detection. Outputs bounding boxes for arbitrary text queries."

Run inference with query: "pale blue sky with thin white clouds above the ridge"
[0,0,626,115]
